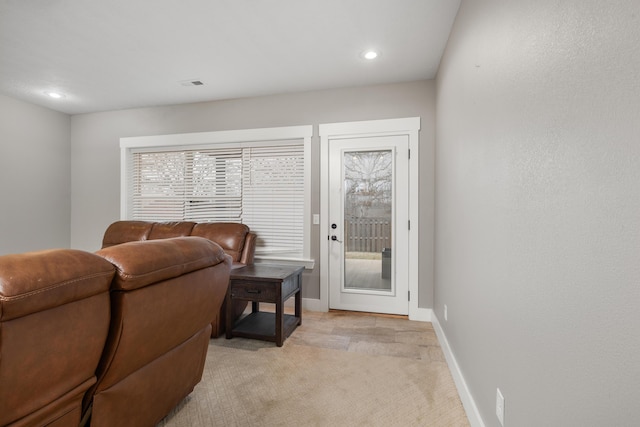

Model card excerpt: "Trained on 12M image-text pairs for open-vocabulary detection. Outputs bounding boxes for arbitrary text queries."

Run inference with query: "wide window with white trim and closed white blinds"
[120,126,313,268]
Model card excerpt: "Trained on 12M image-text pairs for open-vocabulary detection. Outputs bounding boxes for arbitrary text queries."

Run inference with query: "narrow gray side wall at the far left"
[0,95,71,255]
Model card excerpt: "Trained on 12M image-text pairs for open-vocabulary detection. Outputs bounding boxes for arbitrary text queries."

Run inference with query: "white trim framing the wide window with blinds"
[120,125,315,269]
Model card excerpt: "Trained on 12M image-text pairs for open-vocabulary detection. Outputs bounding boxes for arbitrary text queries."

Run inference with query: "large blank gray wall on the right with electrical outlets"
[435,0,640,427]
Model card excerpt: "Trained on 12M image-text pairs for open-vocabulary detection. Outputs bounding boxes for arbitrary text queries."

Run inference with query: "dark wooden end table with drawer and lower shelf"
[226,264,304,347]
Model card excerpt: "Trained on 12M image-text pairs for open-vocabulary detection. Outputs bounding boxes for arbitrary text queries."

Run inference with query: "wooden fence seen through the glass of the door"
[344,218,391,253]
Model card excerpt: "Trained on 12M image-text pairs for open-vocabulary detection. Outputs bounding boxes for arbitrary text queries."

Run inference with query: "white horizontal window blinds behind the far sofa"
[127,140,305,257]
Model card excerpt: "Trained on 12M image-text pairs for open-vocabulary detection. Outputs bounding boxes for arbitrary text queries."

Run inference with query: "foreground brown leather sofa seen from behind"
[0,237,231,427]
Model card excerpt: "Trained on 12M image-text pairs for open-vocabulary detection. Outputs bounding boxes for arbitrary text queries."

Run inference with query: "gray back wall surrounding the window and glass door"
[71,81,435,308]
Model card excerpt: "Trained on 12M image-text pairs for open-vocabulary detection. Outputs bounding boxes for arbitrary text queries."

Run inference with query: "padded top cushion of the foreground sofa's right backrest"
[96,237,226,290]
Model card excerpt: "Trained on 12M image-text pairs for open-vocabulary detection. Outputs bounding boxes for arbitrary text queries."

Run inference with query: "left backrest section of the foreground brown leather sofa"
[0,249,115,425]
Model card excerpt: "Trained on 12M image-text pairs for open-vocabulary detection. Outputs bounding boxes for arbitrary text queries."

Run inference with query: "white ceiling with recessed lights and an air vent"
[0,0,460,114]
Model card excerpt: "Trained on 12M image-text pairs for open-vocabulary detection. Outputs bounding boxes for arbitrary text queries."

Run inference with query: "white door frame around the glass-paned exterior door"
[319,117,421,319]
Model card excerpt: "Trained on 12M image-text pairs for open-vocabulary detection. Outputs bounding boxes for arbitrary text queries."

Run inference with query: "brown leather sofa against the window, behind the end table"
[102,221,256,338]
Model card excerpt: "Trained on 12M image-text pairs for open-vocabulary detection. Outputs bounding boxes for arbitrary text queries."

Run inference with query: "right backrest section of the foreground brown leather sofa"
[84,236,231,427]
